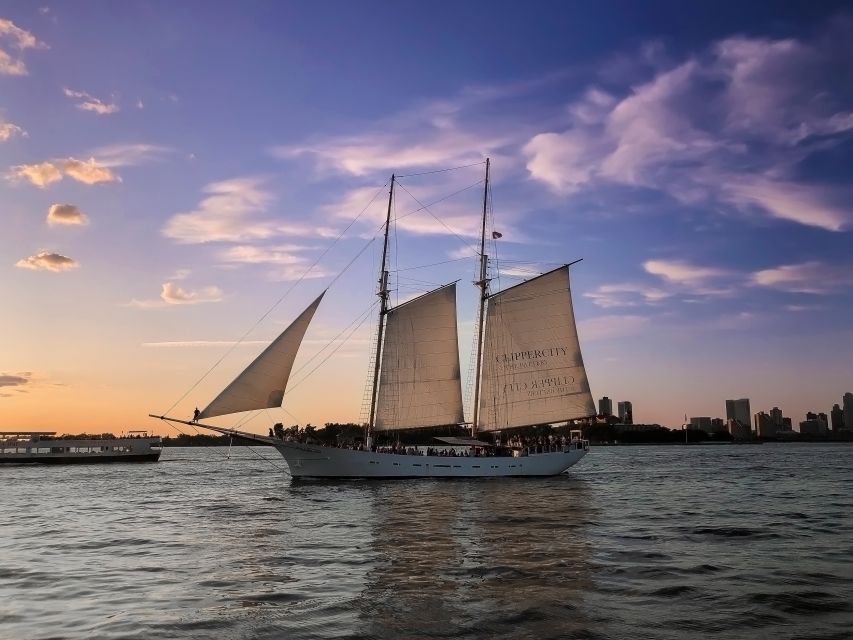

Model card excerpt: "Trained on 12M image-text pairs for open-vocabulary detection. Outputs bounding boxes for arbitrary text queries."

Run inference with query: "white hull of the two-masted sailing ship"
[275,442,587,478]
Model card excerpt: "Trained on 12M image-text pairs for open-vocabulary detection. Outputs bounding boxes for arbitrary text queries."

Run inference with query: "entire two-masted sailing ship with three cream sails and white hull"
[150,160,595,478]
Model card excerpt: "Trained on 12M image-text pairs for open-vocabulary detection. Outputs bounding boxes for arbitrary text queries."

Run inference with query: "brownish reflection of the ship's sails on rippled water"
[357,476,592,638]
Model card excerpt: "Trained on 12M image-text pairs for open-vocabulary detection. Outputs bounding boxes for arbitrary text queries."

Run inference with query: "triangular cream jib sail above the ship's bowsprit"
[198,291,326,418]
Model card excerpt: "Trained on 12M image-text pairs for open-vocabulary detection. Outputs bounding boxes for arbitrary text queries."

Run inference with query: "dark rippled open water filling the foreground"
[0,444,853,640]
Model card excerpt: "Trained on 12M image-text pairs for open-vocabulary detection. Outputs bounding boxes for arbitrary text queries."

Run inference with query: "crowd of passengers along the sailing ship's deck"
[270,430,584,458]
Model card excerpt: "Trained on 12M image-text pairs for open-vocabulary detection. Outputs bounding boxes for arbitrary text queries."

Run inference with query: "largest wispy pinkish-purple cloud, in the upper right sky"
[523,21,853,231]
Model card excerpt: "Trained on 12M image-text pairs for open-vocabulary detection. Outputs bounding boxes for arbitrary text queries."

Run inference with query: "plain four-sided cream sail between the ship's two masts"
[374,283,463,431]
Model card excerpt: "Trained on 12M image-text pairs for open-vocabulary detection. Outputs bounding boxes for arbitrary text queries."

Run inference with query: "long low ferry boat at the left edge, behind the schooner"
[0,431,163,464]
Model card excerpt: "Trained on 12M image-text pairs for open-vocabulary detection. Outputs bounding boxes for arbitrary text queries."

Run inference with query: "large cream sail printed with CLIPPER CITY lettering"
[478,266,595,431]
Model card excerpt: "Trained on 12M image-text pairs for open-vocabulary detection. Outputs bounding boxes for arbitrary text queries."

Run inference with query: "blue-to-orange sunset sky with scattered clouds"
[0,1,853,433]
